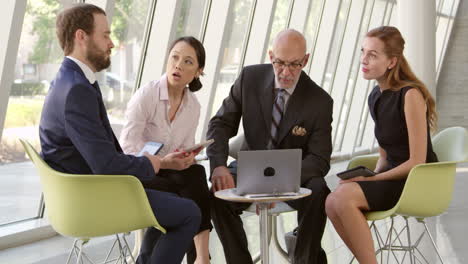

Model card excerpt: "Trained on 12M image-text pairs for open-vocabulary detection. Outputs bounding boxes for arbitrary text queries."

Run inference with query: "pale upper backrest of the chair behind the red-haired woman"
[432,127,468,161]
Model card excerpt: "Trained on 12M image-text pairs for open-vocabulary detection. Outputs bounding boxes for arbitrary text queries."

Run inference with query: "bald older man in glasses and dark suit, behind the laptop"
[207,29,333,264]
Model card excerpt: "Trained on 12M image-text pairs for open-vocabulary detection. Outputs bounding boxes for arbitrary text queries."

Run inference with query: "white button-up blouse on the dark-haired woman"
[119,75,200,156]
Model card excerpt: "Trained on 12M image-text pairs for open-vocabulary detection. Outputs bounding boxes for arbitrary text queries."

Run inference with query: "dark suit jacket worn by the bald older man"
[207,64,333,184]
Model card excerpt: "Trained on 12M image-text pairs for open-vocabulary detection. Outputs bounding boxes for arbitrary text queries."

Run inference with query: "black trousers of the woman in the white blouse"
[140,164,213,264]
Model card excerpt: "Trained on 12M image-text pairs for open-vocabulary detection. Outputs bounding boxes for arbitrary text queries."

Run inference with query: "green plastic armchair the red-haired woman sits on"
[348,127,468,263]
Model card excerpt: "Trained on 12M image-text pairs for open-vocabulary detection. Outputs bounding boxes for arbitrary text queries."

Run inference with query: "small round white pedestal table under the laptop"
[215,188,312,264]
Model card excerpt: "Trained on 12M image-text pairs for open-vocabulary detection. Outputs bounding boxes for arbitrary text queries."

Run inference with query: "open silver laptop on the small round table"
[236,149,302,197]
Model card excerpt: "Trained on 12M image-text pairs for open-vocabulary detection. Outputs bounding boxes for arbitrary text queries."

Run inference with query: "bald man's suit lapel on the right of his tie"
[278,73,310,144]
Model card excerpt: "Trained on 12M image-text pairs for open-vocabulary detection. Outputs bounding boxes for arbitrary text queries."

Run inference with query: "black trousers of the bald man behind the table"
[211,164,330,264]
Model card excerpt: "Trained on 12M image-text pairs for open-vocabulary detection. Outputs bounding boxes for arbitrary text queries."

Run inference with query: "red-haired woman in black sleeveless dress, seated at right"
[325,26,437,264]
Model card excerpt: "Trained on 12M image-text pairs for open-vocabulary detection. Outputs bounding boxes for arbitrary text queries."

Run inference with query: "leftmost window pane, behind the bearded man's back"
[0,0,73,225]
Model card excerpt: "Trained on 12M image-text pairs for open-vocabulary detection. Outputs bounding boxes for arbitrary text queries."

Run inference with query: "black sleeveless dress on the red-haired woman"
[357,86,437,211]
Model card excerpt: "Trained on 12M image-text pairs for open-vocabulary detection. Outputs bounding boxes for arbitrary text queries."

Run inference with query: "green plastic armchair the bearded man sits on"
[20,140,166,263]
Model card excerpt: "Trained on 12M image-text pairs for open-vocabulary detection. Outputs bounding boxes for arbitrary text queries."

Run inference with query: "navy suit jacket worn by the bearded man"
[39,58,155,180]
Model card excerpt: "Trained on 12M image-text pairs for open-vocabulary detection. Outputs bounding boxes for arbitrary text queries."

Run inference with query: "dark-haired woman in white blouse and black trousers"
[120,37,213,264]
